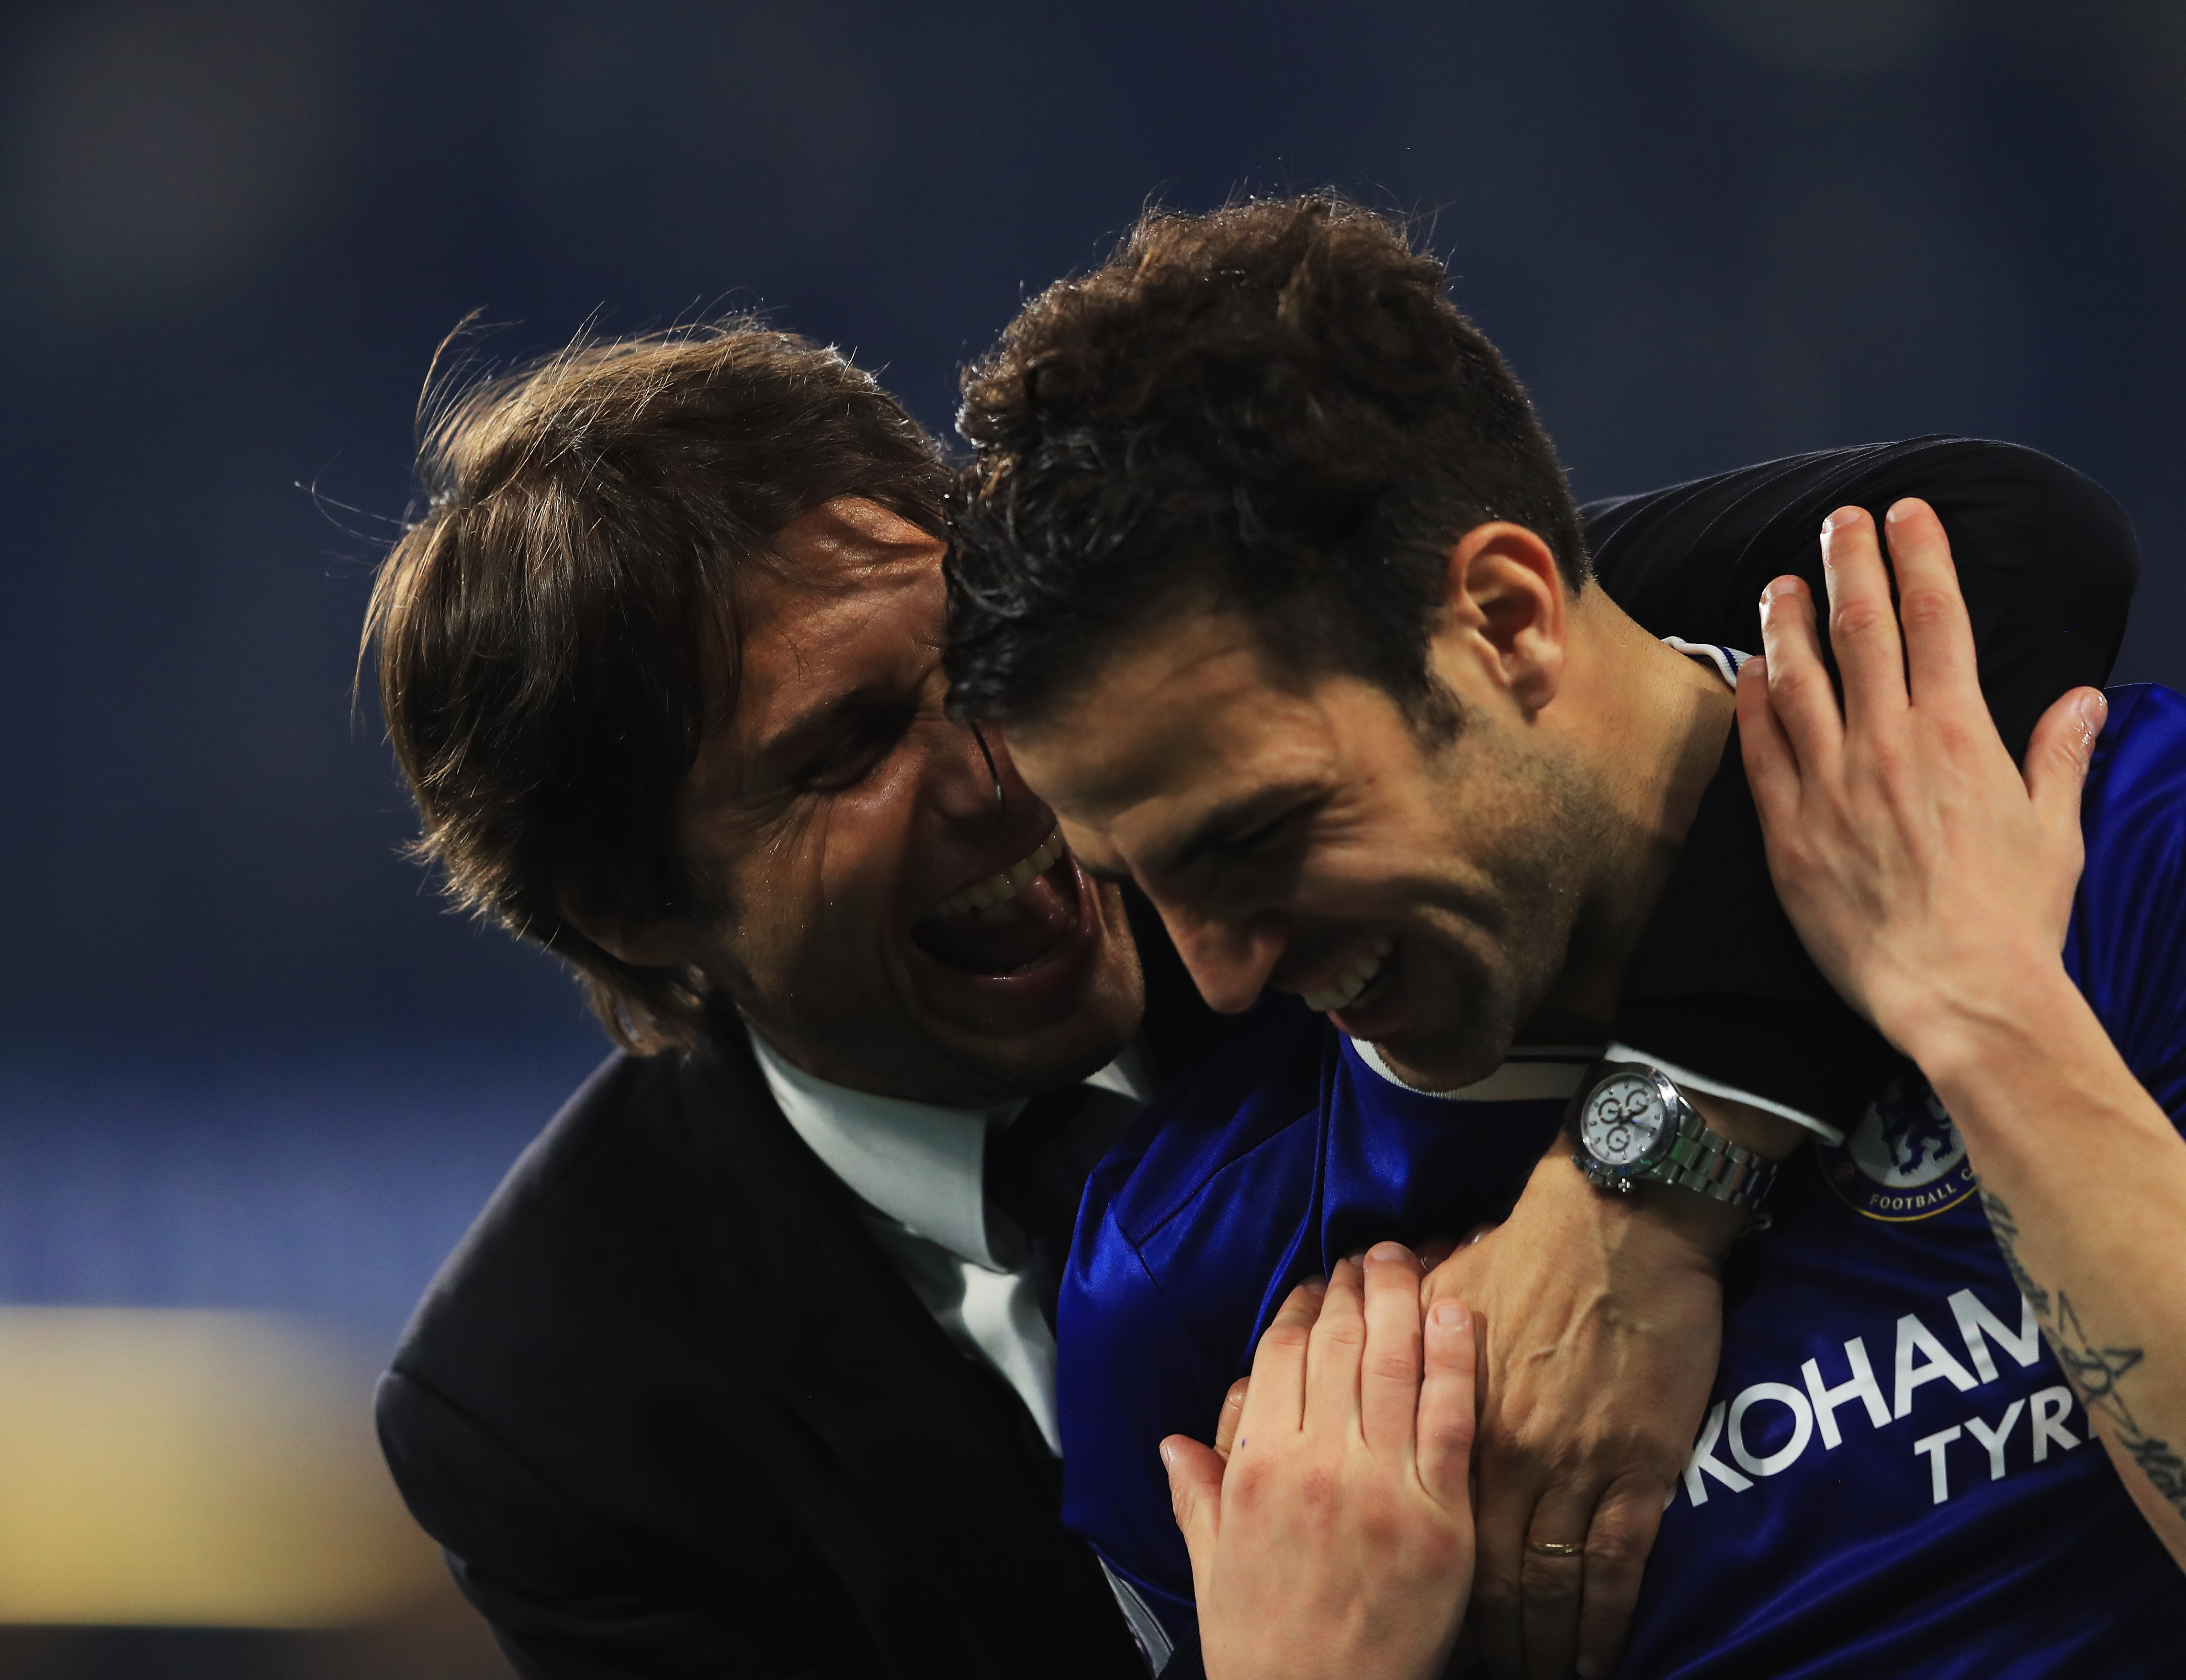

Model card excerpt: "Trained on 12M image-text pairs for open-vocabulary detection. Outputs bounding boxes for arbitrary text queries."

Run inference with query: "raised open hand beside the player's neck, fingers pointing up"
[1738,498,2105,1060]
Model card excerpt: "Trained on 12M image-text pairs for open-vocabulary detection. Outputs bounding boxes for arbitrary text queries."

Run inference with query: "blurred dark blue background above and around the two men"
[0,0,2186,1344]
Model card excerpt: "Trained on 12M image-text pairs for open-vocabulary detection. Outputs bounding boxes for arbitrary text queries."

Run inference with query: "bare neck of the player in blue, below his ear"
[1519,585,1735,1044]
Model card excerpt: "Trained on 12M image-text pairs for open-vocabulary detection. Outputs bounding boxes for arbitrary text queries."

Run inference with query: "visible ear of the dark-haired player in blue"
[1428,520,1569,717]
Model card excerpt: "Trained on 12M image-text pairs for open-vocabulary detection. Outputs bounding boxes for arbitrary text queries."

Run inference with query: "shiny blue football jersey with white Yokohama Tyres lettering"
[1058,686,2186,1680]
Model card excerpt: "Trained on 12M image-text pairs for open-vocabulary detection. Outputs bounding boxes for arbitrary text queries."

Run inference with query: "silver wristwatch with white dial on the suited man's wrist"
[1567,1062,1775,1223]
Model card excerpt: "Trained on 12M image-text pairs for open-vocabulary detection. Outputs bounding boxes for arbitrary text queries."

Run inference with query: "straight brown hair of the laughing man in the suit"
[361,319,947,1053]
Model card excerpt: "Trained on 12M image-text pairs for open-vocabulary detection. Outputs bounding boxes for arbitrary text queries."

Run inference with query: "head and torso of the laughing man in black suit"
[370,308,2125,1678]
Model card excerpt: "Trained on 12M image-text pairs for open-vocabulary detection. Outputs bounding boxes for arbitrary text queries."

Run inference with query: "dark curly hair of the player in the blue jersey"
[949,194,1587,732]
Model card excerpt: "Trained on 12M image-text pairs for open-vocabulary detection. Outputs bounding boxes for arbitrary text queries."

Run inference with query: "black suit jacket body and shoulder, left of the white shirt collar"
[378,1033,1143,1680]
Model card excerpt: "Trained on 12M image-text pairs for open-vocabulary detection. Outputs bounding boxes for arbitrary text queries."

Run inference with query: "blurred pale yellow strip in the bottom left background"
[0,1306,503,1680]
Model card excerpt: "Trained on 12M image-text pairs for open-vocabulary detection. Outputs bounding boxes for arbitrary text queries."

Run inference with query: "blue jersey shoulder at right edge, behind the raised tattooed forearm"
[2066,684,2186,1125]
